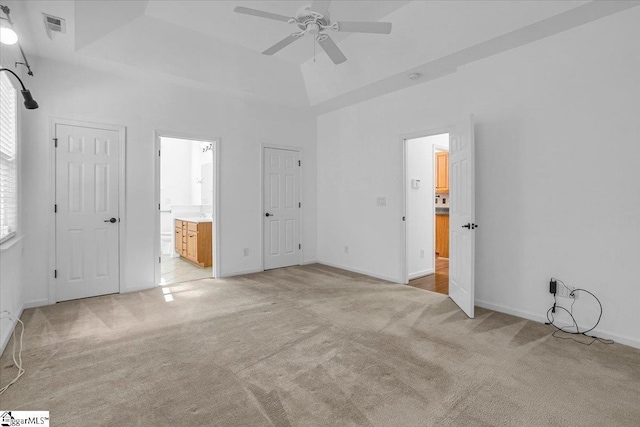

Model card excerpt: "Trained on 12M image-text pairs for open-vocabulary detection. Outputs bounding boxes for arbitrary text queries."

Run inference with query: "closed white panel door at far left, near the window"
[56,124,120,301]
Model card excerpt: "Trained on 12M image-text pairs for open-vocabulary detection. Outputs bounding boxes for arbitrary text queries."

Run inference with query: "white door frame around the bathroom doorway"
[153,129,223,286]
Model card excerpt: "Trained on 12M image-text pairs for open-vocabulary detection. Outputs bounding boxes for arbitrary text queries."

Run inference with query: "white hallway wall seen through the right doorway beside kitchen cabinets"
[405,134,449,279]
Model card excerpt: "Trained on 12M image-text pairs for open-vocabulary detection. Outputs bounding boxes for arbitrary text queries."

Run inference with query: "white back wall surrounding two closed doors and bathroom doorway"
[23,58,316,303]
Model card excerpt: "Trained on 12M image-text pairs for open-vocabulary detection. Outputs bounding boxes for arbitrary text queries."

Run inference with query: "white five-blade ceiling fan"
[234,0,391,65]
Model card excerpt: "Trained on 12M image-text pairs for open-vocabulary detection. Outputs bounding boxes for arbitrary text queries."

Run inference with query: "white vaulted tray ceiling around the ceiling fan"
[3,0,639,110]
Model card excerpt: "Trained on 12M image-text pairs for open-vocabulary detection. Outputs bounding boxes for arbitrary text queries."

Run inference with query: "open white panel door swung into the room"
[449,116,477,318]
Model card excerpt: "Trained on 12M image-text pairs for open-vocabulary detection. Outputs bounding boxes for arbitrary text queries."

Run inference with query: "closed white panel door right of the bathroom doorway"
[263,148,300,270]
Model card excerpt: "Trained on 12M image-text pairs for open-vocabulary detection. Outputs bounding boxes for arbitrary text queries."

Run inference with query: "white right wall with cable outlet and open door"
[318,8,640,346]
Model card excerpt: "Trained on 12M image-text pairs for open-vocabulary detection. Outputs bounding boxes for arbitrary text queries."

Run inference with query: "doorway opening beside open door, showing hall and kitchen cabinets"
[406,133,449,295]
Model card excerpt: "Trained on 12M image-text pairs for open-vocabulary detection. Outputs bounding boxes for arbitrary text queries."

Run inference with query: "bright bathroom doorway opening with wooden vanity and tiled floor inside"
[155,133,219,286]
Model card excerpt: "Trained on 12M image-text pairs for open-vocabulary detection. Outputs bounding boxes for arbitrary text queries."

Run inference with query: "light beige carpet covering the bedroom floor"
[0,265,640,426]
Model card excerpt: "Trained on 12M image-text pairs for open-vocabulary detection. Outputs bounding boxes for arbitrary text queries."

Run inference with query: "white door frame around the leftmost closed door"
[48,117,127,304]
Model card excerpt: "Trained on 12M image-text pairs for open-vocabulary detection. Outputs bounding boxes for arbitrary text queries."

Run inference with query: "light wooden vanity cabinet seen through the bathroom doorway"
[175,220,213,267]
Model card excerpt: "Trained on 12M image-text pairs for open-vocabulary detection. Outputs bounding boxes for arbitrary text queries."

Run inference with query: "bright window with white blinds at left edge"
[0,73,18,243]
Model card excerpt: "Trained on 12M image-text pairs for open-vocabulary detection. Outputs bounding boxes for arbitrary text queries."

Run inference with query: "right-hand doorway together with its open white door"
[401,115,478,318]
